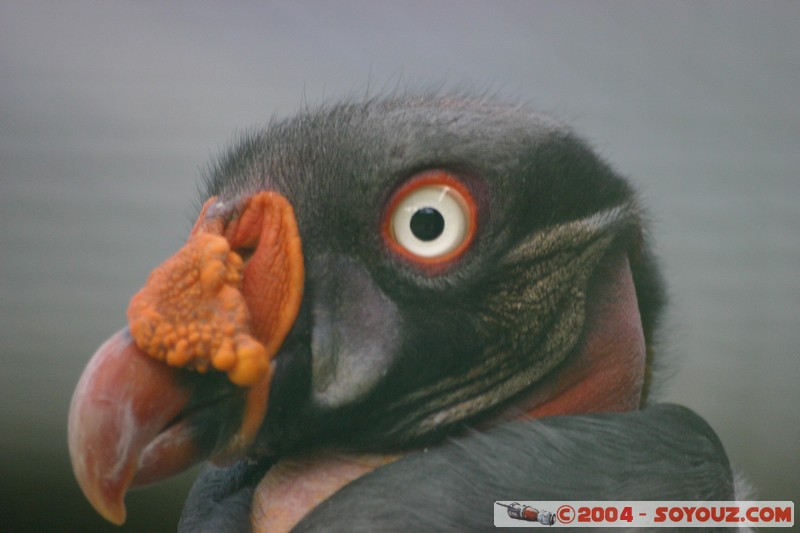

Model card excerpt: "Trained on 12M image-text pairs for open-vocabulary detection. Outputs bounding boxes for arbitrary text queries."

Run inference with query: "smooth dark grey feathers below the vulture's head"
[294,404,734,533]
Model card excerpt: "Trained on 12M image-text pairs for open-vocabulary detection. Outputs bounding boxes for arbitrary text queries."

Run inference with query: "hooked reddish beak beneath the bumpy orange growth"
[68,328,269,525]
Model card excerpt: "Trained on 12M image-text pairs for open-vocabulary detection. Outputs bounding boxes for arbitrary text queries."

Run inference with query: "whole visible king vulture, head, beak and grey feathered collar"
[69,95,732,531]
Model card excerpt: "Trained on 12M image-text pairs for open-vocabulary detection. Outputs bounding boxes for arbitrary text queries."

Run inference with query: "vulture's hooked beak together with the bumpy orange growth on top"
[68,192,304,524]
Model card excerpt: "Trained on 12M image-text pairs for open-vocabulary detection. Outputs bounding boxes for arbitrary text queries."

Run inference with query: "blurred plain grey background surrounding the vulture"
[0,0,800,532]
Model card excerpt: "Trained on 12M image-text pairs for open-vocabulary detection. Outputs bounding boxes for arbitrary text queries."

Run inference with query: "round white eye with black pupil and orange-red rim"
[383,171,477,264]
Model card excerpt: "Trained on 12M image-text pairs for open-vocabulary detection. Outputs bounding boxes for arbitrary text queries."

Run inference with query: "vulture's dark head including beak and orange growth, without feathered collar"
[69,93,662,523]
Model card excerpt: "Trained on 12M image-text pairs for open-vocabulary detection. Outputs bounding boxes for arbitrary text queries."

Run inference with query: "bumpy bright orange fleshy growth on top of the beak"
[128,192,304,387]
